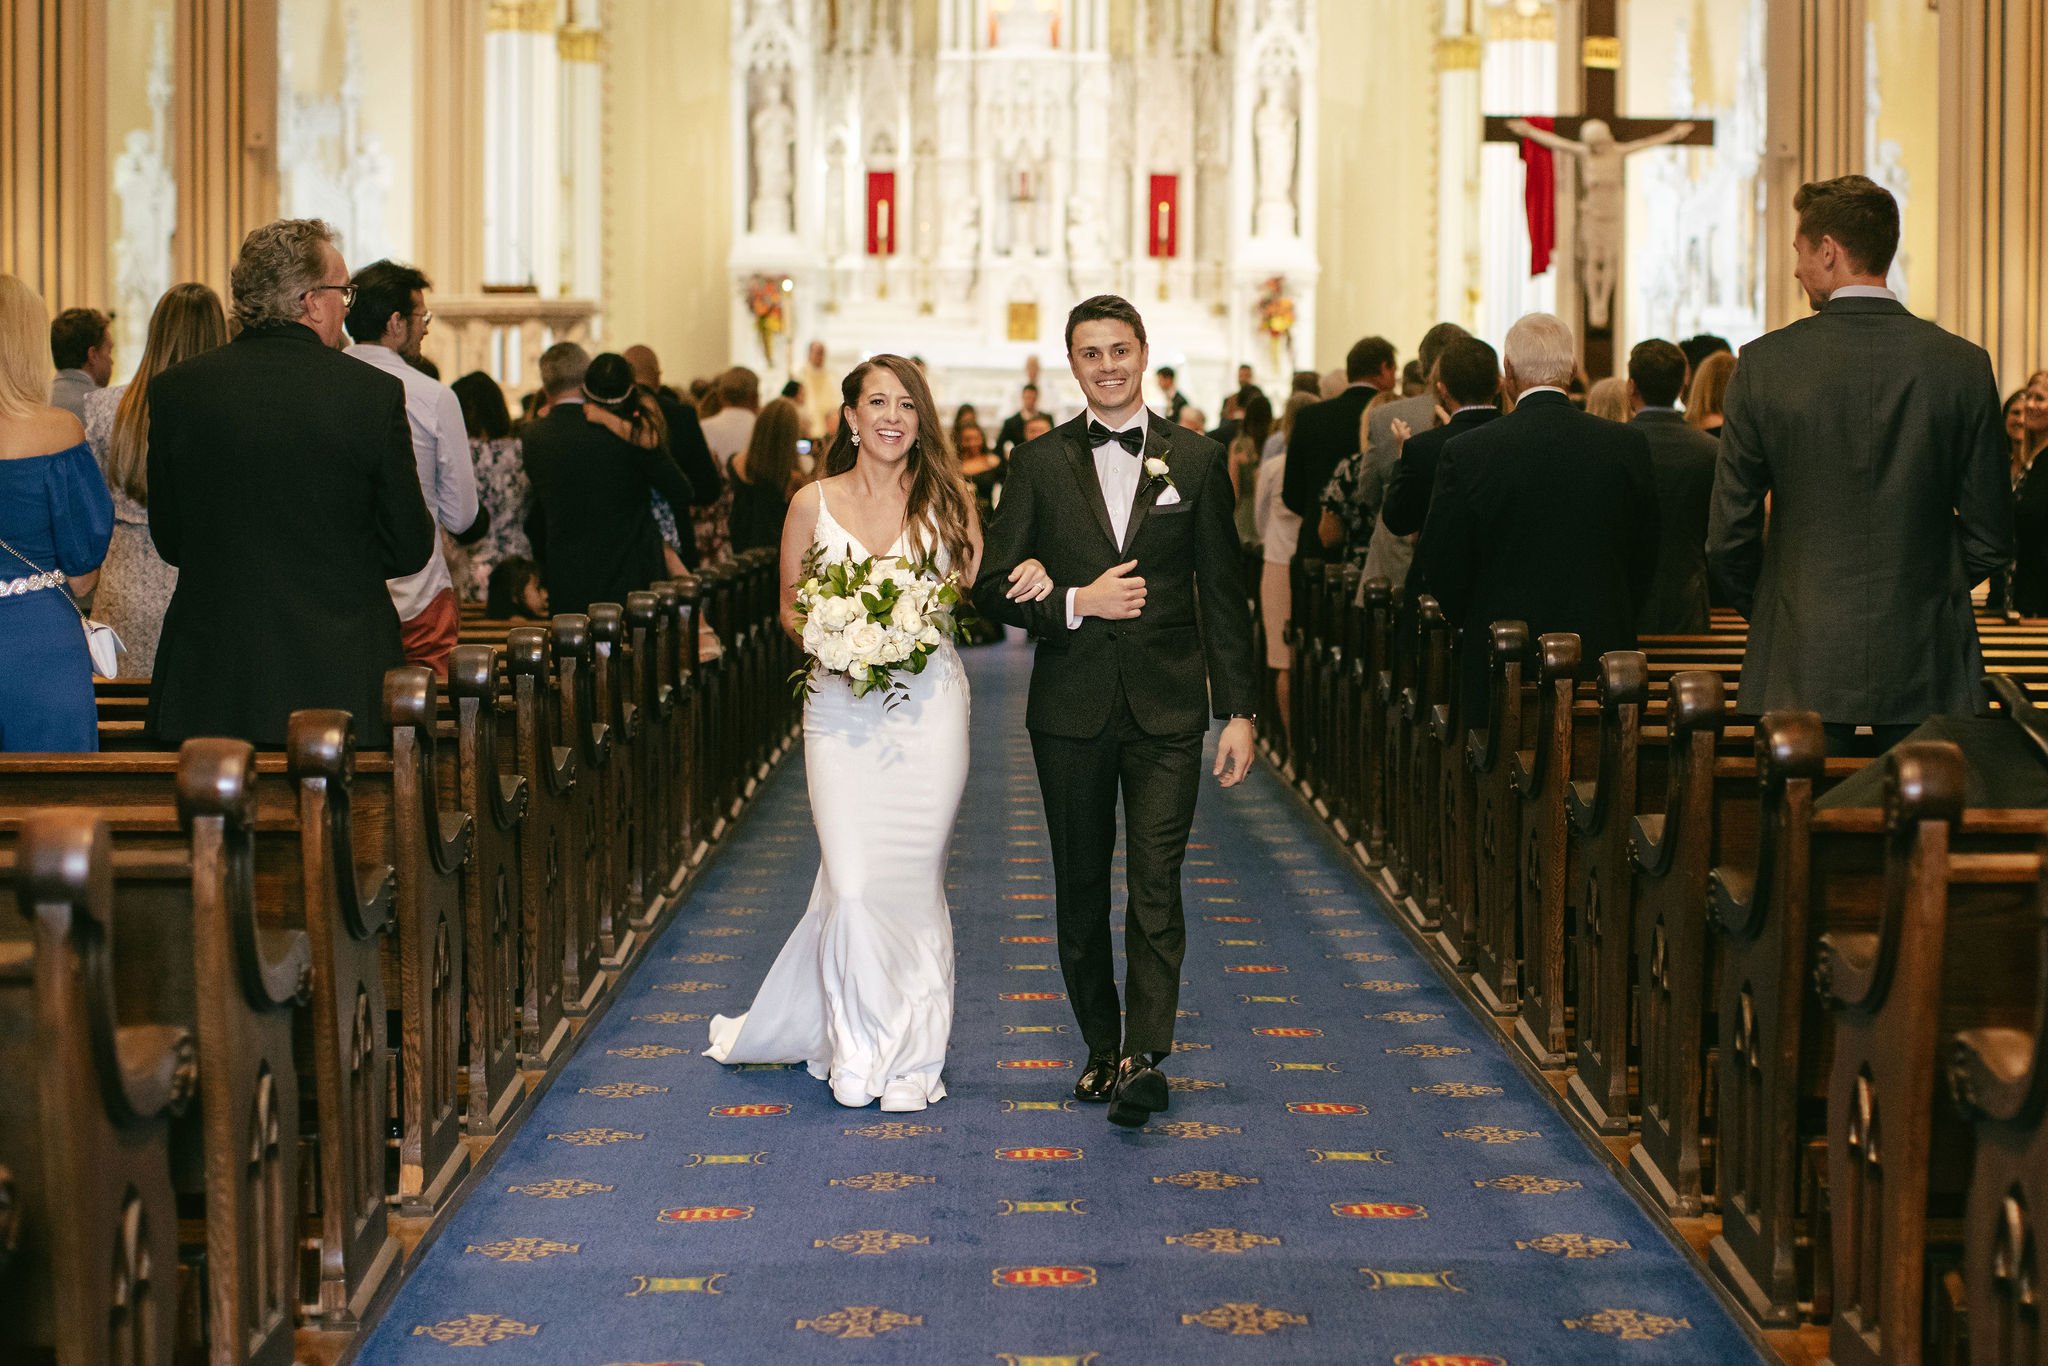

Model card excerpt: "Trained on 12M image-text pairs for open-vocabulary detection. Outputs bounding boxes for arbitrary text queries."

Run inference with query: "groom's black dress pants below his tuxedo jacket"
[1030,688,1202,1057]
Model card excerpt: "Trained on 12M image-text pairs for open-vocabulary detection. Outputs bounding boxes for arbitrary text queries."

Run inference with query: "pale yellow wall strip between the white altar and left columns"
[604,0,733,385]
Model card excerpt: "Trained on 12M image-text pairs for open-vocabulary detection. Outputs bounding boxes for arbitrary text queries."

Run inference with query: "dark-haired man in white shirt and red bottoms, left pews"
[344,260,489,680]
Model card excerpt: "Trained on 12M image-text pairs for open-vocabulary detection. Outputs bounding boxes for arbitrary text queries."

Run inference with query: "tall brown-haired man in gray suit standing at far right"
[1706,176,2013,754]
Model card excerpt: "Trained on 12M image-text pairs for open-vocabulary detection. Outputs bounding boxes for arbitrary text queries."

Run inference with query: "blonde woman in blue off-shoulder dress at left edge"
[0,274,115,754]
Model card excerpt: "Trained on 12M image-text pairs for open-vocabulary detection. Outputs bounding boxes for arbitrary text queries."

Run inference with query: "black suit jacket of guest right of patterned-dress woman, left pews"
[522,401,690,612]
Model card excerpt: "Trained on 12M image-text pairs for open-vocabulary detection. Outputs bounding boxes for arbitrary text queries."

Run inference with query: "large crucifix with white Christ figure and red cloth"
[1487,0,1714,379]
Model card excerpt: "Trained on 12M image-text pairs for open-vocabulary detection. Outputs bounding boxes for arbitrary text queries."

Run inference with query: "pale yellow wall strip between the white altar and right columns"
[1300,0,1436,371]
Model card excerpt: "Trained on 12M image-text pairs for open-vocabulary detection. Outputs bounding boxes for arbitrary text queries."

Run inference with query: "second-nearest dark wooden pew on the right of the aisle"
[1817,741,2048,1366]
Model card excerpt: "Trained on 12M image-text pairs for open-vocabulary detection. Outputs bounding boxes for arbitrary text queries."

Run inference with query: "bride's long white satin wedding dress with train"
[705,487,969,1110]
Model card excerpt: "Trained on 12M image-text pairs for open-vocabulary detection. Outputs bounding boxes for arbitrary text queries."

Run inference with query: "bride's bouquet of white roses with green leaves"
[791,547,961,705]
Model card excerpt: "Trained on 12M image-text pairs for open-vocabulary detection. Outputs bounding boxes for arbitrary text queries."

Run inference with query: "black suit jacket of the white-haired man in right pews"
[1415,391,1657,725]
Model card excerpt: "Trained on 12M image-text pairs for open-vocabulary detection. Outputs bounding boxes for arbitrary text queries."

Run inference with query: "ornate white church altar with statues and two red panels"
[729,0,1319,422]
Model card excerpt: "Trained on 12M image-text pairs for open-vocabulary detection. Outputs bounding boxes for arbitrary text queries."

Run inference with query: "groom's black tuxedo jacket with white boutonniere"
[975,410,1255,739]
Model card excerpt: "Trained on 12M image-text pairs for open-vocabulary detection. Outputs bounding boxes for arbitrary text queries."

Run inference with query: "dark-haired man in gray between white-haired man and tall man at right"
[1628,342,1720,635]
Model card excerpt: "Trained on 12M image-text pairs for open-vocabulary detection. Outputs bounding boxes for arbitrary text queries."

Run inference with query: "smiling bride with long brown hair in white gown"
[705,354,1051,1112]
